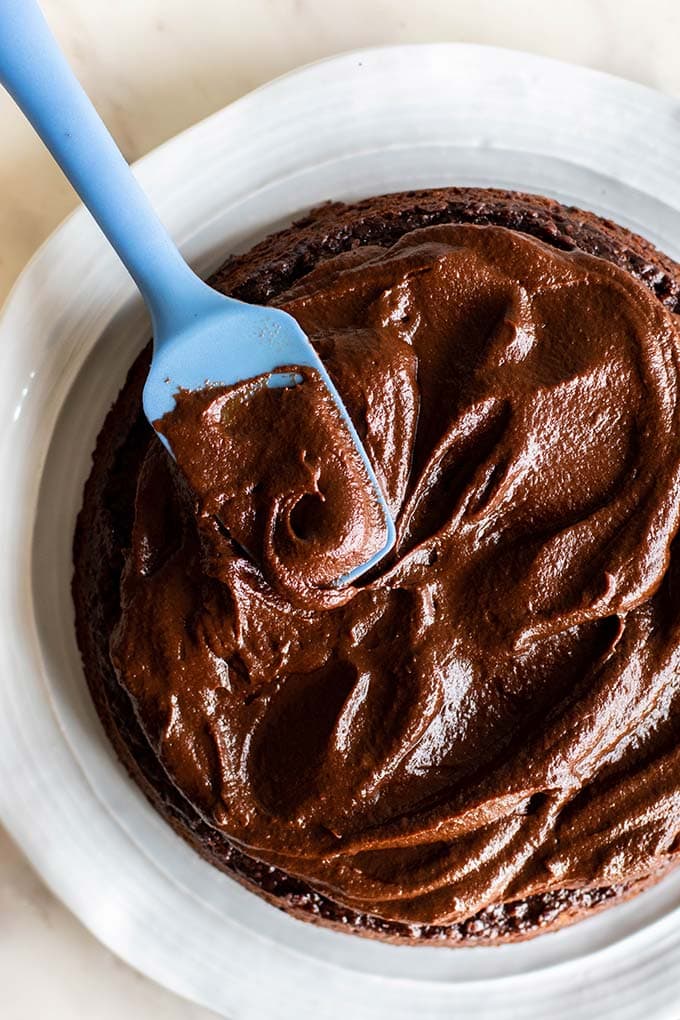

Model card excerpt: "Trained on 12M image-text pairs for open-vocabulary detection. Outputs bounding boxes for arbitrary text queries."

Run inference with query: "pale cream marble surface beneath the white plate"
[0,0,680,1020]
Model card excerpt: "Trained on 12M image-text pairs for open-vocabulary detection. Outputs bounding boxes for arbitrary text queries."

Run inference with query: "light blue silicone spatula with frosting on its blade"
[0,0,395,583]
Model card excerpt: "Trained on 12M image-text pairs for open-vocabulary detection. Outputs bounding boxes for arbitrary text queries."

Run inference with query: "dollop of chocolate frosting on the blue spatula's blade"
[156,365,386,609]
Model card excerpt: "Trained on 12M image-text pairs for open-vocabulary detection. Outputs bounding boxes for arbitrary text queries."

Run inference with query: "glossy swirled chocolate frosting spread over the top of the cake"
[111,225,680,923]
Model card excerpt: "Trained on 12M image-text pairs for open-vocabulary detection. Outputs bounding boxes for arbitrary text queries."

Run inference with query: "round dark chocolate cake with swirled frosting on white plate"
[73,188,680,946]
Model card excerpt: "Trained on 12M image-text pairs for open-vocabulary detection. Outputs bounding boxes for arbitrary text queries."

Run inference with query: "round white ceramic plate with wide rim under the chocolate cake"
[0,44,680,1020]
